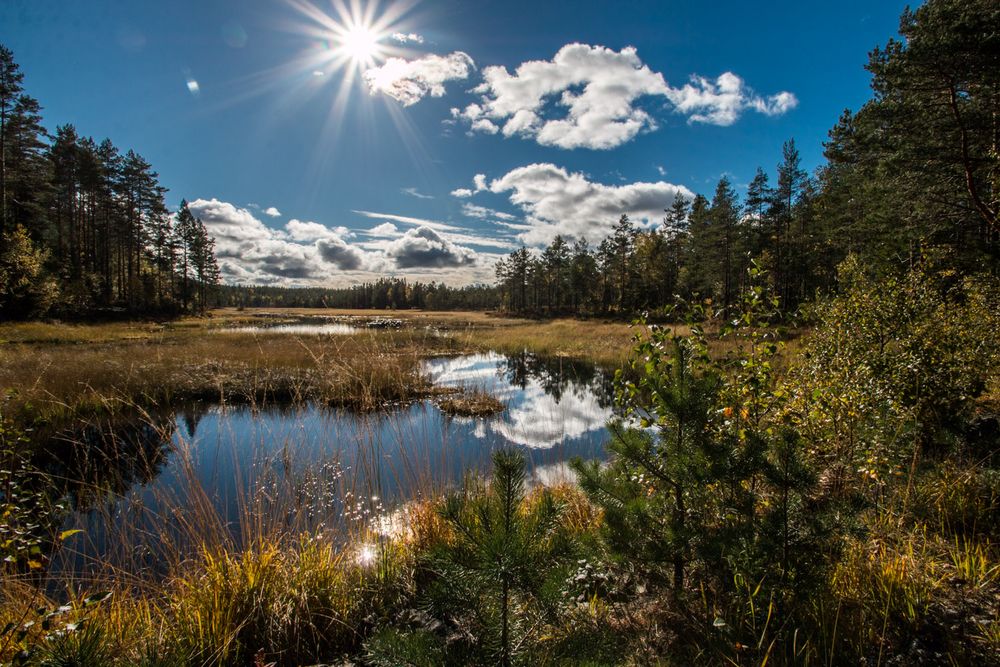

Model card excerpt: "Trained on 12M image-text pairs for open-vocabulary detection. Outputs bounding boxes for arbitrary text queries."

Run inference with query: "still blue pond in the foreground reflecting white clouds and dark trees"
[50,353,613,572]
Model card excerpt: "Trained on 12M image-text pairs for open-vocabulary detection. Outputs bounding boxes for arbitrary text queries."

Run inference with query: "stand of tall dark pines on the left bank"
[0,46,220,319]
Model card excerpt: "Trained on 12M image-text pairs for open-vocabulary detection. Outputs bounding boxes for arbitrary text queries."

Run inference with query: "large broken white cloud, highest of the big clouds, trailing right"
[451,44,797,150]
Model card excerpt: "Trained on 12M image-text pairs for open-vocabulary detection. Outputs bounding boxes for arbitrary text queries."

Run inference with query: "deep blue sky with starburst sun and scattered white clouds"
[0,0,905,285]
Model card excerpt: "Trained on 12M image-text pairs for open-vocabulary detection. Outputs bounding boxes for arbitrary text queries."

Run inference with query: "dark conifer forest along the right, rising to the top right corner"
[496,2,1000,314]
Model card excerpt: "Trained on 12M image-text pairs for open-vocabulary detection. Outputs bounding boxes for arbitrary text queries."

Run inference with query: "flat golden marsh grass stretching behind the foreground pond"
[0,309,632,418]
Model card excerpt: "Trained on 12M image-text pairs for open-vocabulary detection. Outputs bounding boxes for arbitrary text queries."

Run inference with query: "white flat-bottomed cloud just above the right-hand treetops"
[478,163,694,245]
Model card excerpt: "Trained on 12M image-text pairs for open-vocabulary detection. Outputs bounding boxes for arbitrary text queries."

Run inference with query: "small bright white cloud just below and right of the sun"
[364,51,476,107]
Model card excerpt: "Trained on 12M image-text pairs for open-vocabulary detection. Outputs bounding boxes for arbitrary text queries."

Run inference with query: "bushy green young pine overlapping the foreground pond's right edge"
[572,327,719,595]
